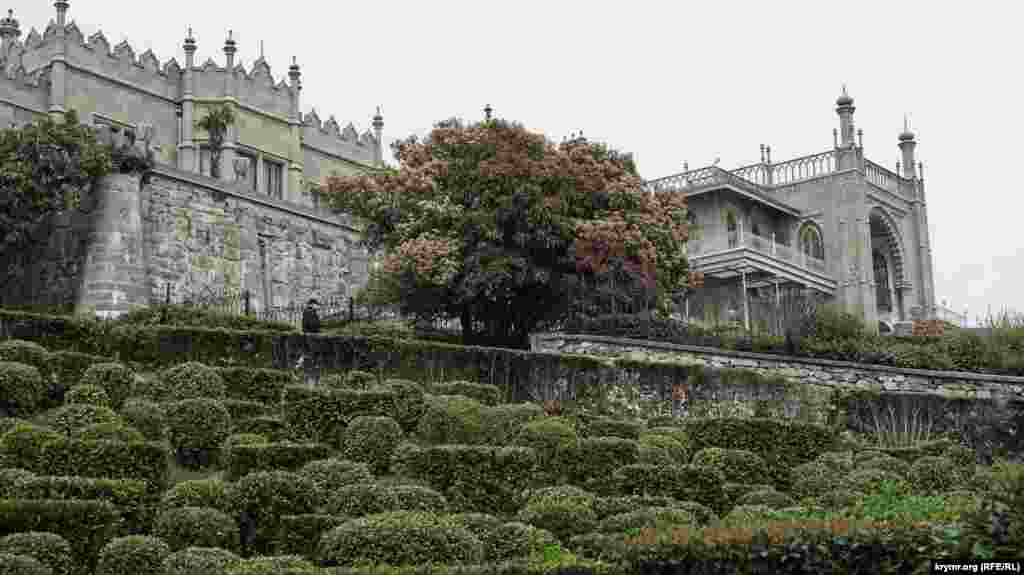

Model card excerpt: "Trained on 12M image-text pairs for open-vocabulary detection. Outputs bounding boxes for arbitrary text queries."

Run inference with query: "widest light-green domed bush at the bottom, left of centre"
[318,512,483,567]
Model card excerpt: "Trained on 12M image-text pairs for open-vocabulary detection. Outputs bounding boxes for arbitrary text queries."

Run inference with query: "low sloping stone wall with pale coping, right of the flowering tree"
[530,334,1024,402]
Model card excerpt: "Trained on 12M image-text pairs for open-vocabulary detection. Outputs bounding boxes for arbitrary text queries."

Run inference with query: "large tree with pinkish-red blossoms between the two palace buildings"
[319,120,704,347]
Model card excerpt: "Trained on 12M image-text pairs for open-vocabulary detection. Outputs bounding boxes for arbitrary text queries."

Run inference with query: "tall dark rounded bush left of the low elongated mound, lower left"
[230,472,317,555]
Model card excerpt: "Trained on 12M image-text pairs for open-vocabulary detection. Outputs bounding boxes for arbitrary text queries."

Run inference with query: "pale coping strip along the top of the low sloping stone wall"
[529,333,1024,385]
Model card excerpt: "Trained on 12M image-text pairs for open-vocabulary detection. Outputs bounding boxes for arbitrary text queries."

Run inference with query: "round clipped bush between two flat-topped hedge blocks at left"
[167,399,231,467]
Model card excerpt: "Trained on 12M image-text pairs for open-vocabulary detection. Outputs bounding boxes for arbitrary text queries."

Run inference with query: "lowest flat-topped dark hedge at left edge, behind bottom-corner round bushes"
[0,499,122,573]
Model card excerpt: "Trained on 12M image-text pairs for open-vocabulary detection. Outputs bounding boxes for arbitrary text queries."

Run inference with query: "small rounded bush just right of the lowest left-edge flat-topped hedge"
[153,507,239,551]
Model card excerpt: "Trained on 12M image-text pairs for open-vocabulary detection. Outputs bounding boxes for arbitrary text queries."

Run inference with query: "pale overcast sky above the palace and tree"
[10,0,1024,320]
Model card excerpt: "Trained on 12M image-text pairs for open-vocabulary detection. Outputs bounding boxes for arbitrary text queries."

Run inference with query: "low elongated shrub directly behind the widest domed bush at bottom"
[325,483,447,517]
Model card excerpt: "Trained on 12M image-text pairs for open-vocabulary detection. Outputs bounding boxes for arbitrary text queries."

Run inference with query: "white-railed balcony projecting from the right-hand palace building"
[686,229,836,296]
